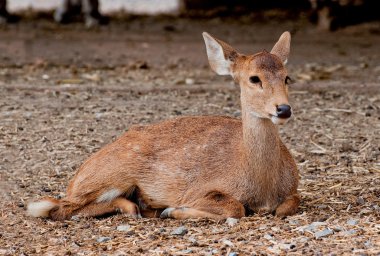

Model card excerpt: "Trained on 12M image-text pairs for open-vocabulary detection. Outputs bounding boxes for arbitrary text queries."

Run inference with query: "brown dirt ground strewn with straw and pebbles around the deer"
[0,18,380,256]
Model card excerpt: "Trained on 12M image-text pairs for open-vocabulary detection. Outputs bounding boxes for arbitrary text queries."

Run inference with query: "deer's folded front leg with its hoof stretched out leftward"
[160,191,245,220]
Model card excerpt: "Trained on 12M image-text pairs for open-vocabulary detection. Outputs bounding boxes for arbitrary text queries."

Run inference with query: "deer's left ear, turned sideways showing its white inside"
[202,32,239,75]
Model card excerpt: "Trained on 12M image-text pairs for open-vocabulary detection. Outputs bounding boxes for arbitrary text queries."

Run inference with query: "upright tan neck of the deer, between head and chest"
[242,104,281,173]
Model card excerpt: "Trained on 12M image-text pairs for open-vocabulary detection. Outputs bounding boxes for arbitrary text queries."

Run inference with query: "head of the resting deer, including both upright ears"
[203,32,292,124]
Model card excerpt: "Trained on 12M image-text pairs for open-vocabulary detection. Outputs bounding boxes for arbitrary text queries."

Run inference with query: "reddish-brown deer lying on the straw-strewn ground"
[27,32,300,220]
